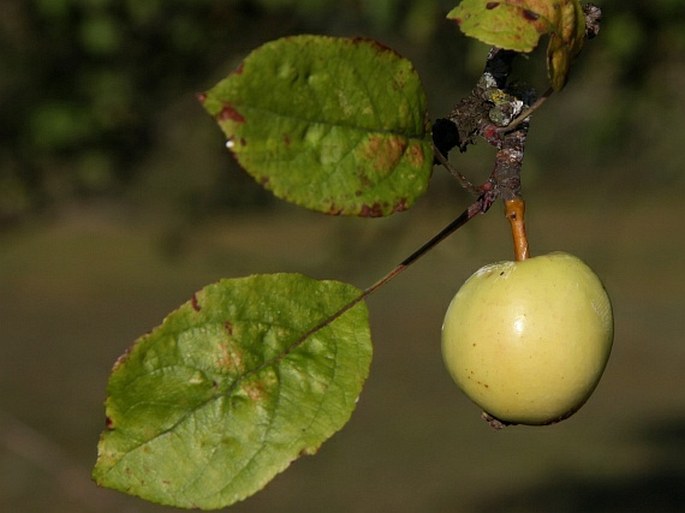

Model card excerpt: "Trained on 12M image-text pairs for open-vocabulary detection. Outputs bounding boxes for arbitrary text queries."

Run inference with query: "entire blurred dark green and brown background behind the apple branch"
[0,0,685,513]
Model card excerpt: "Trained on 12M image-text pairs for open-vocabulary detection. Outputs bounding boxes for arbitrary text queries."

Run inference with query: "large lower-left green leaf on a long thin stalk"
[93,274,371,509]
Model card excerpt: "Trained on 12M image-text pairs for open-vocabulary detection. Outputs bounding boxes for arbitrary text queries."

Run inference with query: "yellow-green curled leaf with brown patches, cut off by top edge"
[447,0,585,91]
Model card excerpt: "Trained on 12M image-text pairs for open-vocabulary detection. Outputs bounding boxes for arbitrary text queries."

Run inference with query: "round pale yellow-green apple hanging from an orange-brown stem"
[442,252,614,425]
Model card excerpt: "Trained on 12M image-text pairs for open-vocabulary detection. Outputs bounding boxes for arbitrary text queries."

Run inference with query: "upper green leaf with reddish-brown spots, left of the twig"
[201,36,433,216]
